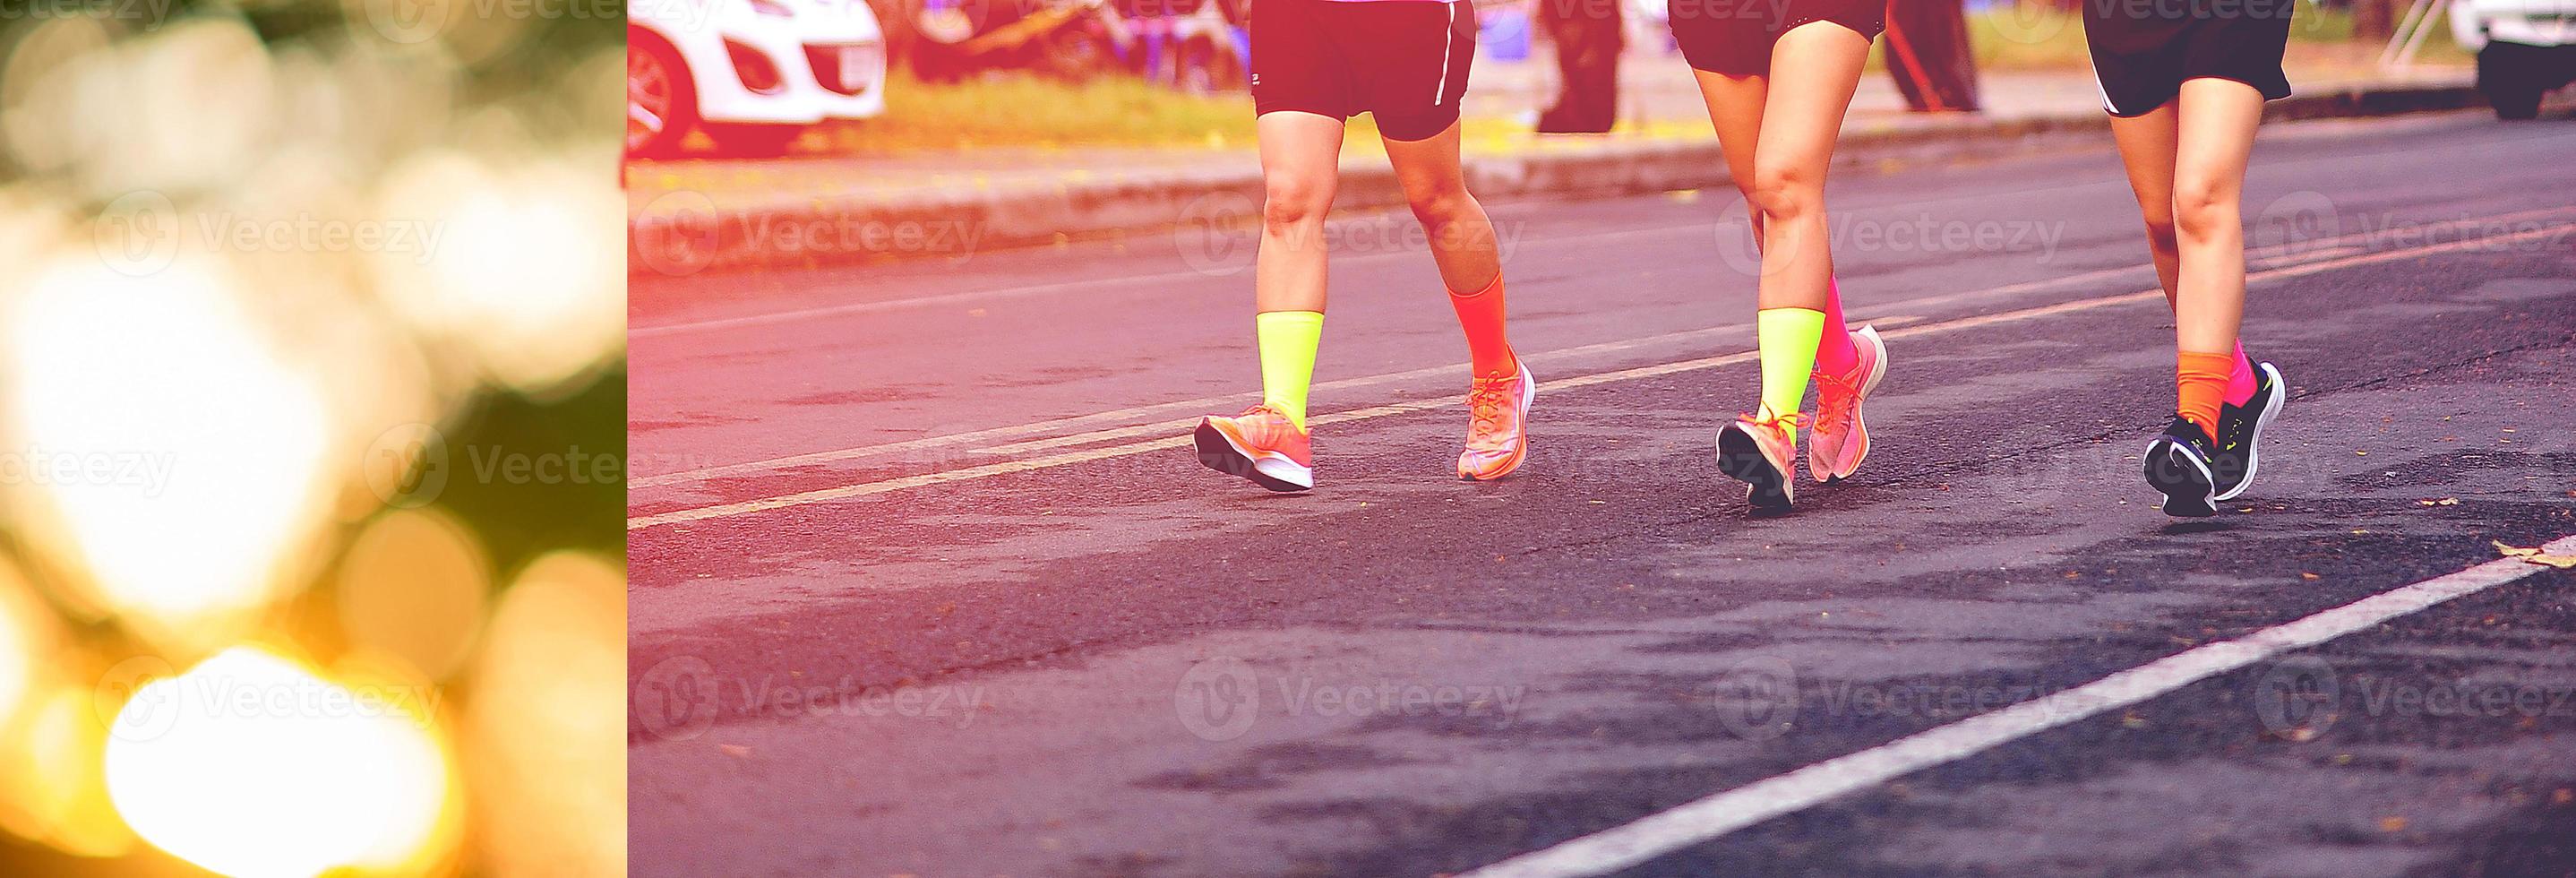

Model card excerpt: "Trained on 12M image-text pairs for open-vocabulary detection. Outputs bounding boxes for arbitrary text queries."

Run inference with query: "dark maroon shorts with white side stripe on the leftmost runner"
[1252,0,1476,142]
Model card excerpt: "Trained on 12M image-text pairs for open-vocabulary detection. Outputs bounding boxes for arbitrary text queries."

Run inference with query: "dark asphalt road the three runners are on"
[629,113,2576,875]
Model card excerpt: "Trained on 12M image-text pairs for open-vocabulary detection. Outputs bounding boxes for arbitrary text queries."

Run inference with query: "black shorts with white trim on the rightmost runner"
[2084,0,2297,118]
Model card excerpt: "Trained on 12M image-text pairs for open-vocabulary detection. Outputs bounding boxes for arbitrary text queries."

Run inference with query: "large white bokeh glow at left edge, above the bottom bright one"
[5,257,324,636]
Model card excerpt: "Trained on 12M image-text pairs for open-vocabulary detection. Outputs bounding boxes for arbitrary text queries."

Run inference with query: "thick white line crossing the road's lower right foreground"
[1461,536,2576,878]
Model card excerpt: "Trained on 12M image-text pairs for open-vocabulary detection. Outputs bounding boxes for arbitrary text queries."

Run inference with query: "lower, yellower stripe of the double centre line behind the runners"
[626,224,2571,530]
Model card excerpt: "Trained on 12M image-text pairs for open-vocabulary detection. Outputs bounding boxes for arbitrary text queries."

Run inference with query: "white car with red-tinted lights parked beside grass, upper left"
[626,0,886,157]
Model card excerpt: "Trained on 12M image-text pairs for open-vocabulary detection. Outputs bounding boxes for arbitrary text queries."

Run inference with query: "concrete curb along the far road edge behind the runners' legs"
[626,85,2486,276]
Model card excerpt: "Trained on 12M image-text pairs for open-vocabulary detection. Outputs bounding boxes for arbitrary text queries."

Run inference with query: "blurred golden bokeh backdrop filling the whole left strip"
[0,0,626,875]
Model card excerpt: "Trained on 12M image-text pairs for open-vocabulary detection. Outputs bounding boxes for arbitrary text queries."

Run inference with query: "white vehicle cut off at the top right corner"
[2450,0,2576,118]
